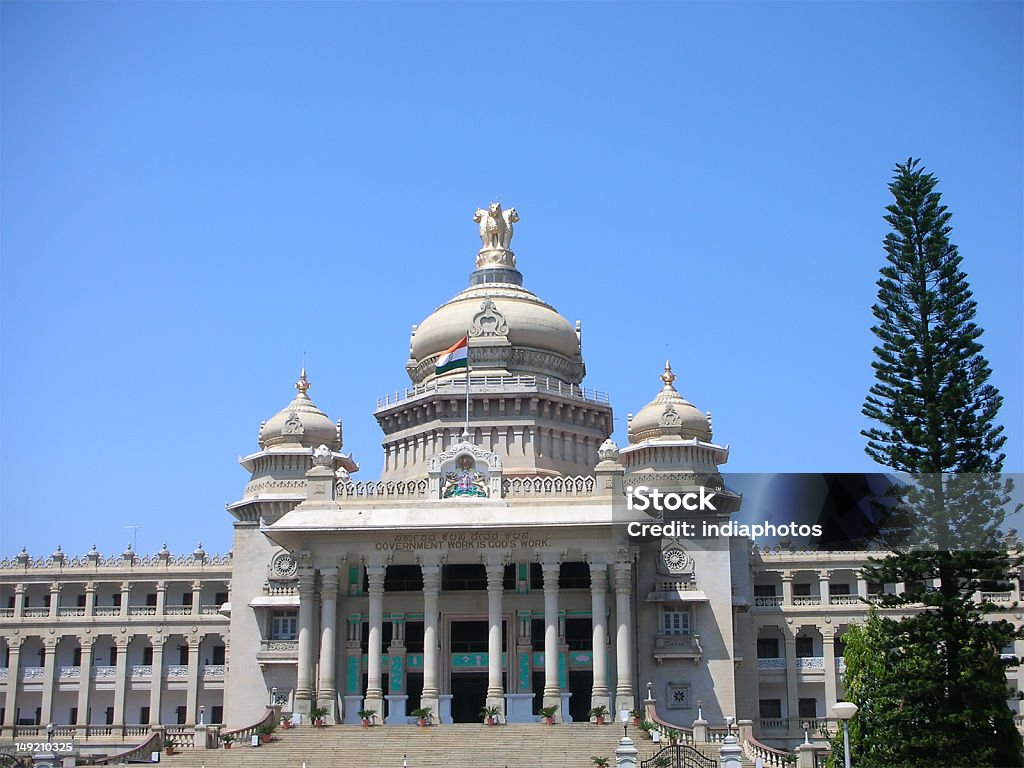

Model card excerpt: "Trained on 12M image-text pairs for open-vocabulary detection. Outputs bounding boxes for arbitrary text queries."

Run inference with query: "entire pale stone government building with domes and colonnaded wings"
[0,203,1024,746]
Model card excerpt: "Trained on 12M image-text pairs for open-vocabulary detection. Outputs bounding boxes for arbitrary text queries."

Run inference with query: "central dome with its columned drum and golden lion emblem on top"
[375,203,612,480]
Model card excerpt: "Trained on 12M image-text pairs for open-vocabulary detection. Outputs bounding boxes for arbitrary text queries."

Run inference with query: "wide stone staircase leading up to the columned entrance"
[155,723,753,768]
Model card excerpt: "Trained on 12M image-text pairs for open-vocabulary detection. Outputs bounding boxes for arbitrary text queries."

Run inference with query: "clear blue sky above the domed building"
[0,2,1024,555]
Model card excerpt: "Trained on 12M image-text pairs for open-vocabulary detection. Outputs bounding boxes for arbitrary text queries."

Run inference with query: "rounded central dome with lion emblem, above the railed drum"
[407,203,586,384]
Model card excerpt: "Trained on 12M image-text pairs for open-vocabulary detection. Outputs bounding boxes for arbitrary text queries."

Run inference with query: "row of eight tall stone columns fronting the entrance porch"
[295,560,634,713]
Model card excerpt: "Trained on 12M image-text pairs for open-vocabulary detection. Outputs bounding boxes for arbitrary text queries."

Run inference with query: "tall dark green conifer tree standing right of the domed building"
[840,159,1024,768]
